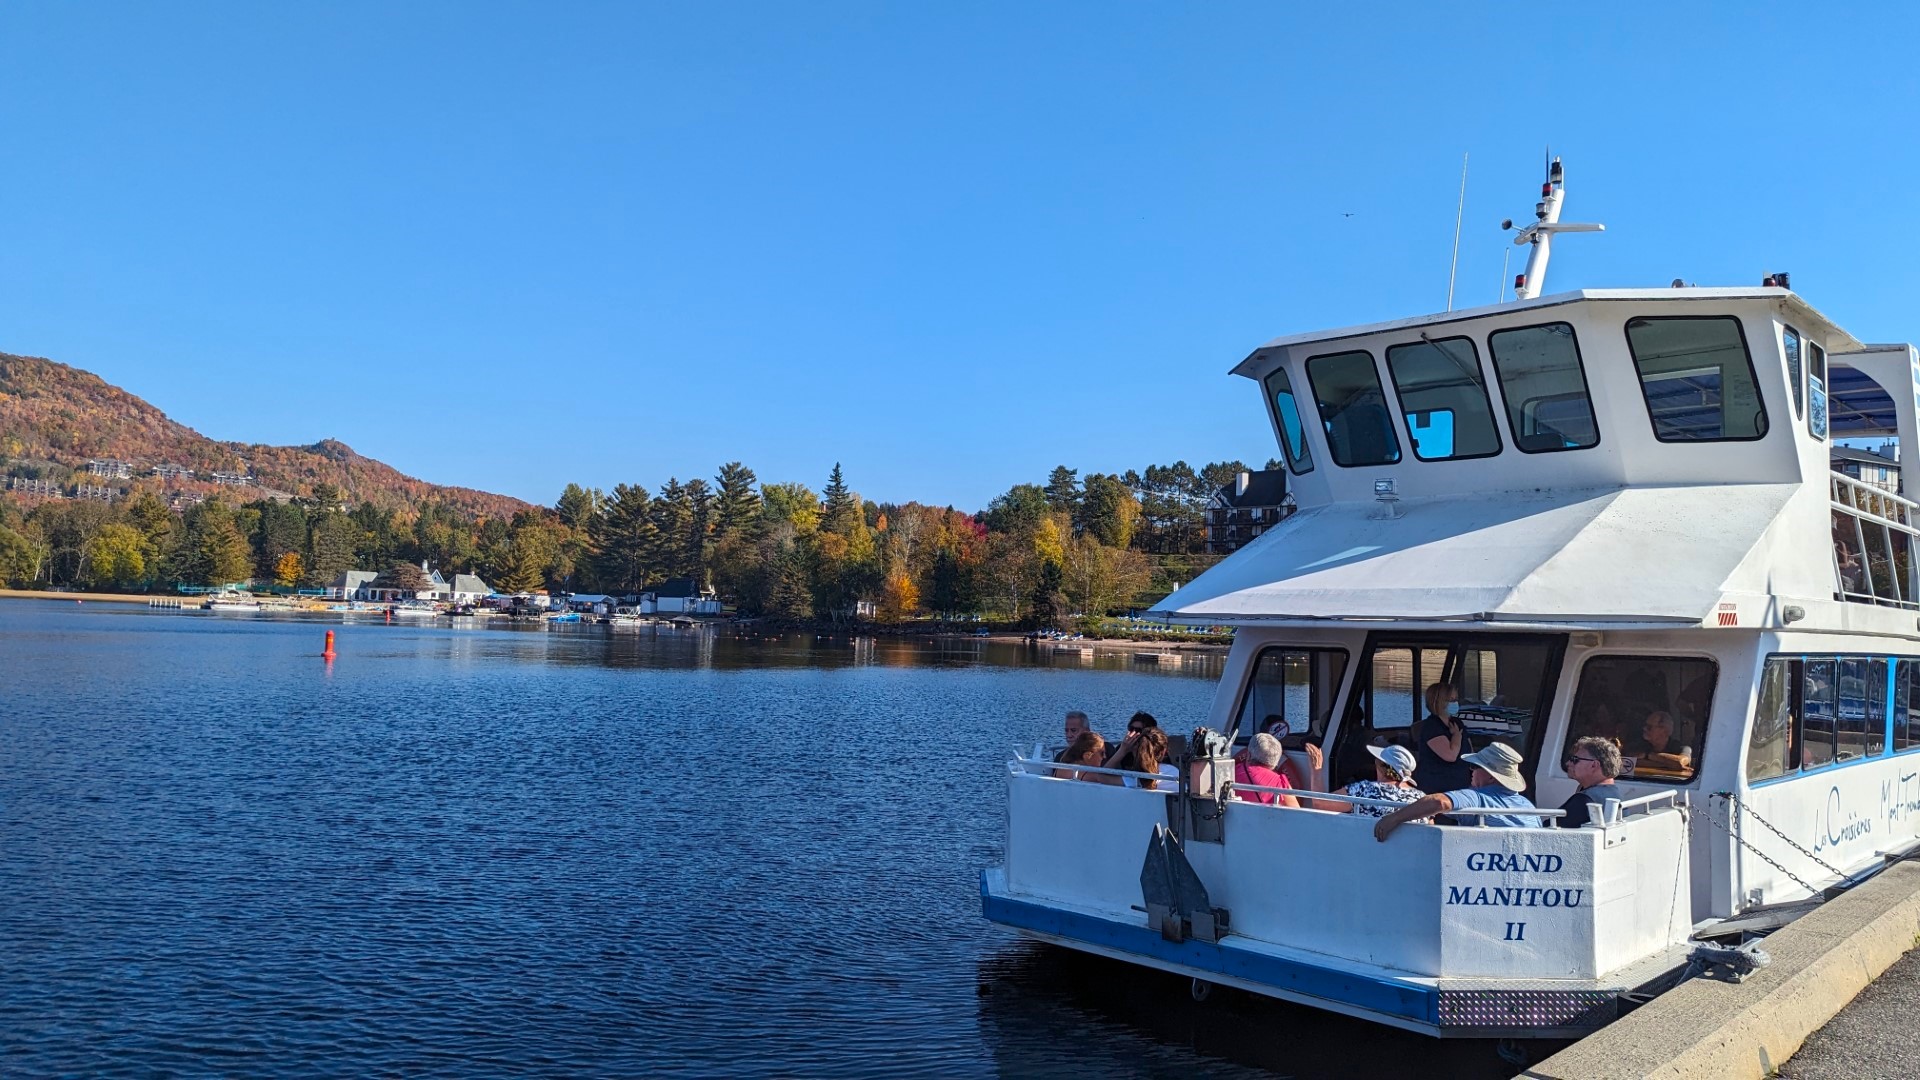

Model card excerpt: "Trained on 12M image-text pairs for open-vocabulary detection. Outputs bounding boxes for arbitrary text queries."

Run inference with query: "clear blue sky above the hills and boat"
[0,2,1920,509]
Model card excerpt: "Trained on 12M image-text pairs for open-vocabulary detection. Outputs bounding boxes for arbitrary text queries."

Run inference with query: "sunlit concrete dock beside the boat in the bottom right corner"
[1521,863,1920,1080]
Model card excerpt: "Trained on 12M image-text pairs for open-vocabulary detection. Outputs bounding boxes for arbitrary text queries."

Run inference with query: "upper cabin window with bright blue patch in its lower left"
[1386,338,1500,461]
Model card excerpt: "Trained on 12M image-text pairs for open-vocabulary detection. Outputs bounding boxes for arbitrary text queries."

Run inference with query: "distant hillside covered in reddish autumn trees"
[0,352,528,517]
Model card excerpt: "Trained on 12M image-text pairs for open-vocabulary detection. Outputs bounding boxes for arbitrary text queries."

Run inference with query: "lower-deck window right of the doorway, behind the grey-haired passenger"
[1561,655,1718,784]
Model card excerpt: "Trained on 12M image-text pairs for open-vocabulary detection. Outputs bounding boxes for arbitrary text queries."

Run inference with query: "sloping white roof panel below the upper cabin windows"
[1154,484,1832,625]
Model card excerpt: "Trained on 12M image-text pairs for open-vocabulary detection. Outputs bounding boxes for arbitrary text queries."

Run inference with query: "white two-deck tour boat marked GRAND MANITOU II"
[981,161,1920,1036]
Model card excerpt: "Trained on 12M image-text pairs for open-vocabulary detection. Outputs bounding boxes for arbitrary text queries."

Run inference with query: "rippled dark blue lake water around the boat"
[0,601,1513,1078]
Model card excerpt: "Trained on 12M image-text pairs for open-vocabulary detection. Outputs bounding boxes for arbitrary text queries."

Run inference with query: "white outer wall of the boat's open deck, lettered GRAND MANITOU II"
[1006,774,1692,978]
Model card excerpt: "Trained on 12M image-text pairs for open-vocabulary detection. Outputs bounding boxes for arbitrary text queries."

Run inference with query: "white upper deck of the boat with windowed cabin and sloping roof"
[1160,286,1920,636]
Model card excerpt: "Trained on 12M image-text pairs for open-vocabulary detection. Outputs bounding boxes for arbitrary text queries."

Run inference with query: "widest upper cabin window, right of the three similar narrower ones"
[1626,315,1766,442]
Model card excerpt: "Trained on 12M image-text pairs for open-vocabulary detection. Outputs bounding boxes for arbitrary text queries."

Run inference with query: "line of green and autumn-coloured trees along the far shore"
[0,453,1275,625]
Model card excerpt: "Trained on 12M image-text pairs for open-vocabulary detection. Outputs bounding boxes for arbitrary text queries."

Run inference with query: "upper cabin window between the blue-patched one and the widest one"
[1486,323,1599,454]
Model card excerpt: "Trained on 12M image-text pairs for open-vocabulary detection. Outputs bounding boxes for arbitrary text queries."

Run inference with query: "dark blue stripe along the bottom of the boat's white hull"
[979,871,1440,1026]
